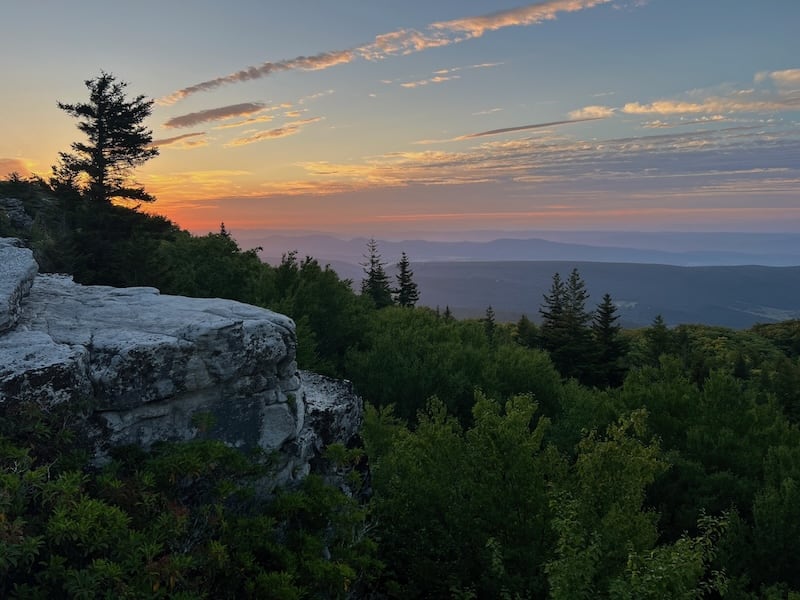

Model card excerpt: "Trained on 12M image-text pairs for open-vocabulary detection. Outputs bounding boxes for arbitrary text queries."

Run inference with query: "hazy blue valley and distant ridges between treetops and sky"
[223,230,800,328]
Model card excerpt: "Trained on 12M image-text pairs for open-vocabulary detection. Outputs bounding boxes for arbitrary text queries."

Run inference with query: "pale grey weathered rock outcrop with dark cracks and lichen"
[0,240,361,483]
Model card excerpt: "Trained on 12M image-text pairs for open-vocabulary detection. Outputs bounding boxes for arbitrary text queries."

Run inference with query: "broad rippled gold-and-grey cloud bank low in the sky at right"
[268,121,800,202]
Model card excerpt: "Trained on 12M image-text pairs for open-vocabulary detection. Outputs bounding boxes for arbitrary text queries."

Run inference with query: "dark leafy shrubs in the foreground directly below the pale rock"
[0,400,380,599]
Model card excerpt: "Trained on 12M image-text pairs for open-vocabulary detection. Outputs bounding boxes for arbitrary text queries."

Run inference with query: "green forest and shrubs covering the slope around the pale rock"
[0,178,800,599]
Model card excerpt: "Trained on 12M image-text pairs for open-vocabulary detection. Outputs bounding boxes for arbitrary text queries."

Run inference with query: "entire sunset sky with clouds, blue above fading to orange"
[0,0,800,237]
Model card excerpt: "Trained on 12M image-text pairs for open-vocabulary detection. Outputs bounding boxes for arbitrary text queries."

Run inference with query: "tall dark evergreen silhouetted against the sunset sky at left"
[53,73,158,202]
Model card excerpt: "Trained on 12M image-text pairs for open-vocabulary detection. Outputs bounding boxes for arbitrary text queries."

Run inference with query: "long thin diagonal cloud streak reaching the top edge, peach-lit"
[158,0,611,105]
